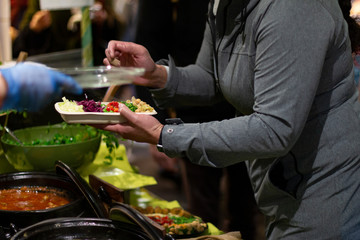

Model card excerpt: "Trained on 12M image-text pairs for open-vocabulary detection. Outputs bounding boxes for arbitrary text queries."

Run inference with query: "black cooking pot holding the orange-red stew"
[0,172,93,228]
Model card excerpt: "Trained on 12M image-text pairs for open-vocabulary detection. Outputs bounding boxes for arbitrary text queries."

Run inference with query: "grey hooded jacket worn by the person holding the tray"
[152,0,360,240]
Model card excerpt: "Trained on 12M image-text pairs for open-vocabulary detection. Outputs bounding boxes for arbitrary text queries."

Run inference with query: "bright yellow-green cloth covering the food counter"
[0,142,241,240]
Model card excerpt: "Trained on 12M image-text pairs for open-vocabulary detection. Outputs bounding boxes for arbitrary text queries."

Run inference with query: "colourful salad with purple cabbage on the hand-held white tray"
[59,97,155,113]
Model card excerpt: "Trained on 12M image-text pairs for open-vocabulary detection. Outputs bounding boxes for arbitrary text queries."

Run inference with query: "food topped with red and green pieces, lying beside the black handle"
[133,206,207,236]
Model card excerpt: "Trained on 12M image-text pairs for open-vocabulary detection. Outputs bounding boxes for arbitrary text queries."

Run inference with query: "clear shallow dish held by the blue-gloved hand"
[55,66,145,88]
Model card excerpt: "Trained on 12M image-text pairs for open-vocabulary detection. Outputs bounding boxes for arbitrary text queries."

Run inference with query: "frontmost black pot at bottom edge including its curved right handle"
[7,203,174,240]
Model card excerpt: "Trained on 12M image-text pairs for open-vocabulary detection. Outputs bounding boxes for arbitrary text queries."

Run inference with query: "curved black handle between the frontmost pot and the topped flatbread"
[109,202,175,240]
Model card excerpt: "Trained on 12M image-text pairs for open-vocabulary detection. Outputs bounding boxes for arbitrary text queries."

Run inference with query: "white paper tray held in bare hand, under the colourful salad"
[55,102,157,124]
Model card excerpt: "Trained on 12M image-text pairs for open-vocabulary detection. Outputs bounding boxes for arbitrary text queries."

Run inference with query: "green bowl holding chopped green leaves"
[1,125,101,171]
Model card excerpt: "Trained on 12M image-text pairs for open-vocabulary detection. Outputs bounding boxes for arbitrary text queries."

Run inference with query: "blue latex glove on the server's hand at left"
[0,63,82,112]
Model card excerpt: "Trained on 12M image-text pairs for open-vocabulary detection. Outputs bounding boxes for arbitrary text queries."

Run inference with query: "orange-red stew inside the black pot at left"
[0,186,70,211]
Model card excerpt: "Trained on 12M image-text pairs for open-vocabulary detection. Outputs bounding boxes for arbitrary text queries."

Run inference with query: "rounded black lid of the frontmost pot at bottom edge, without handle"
[11,218,172,240]
